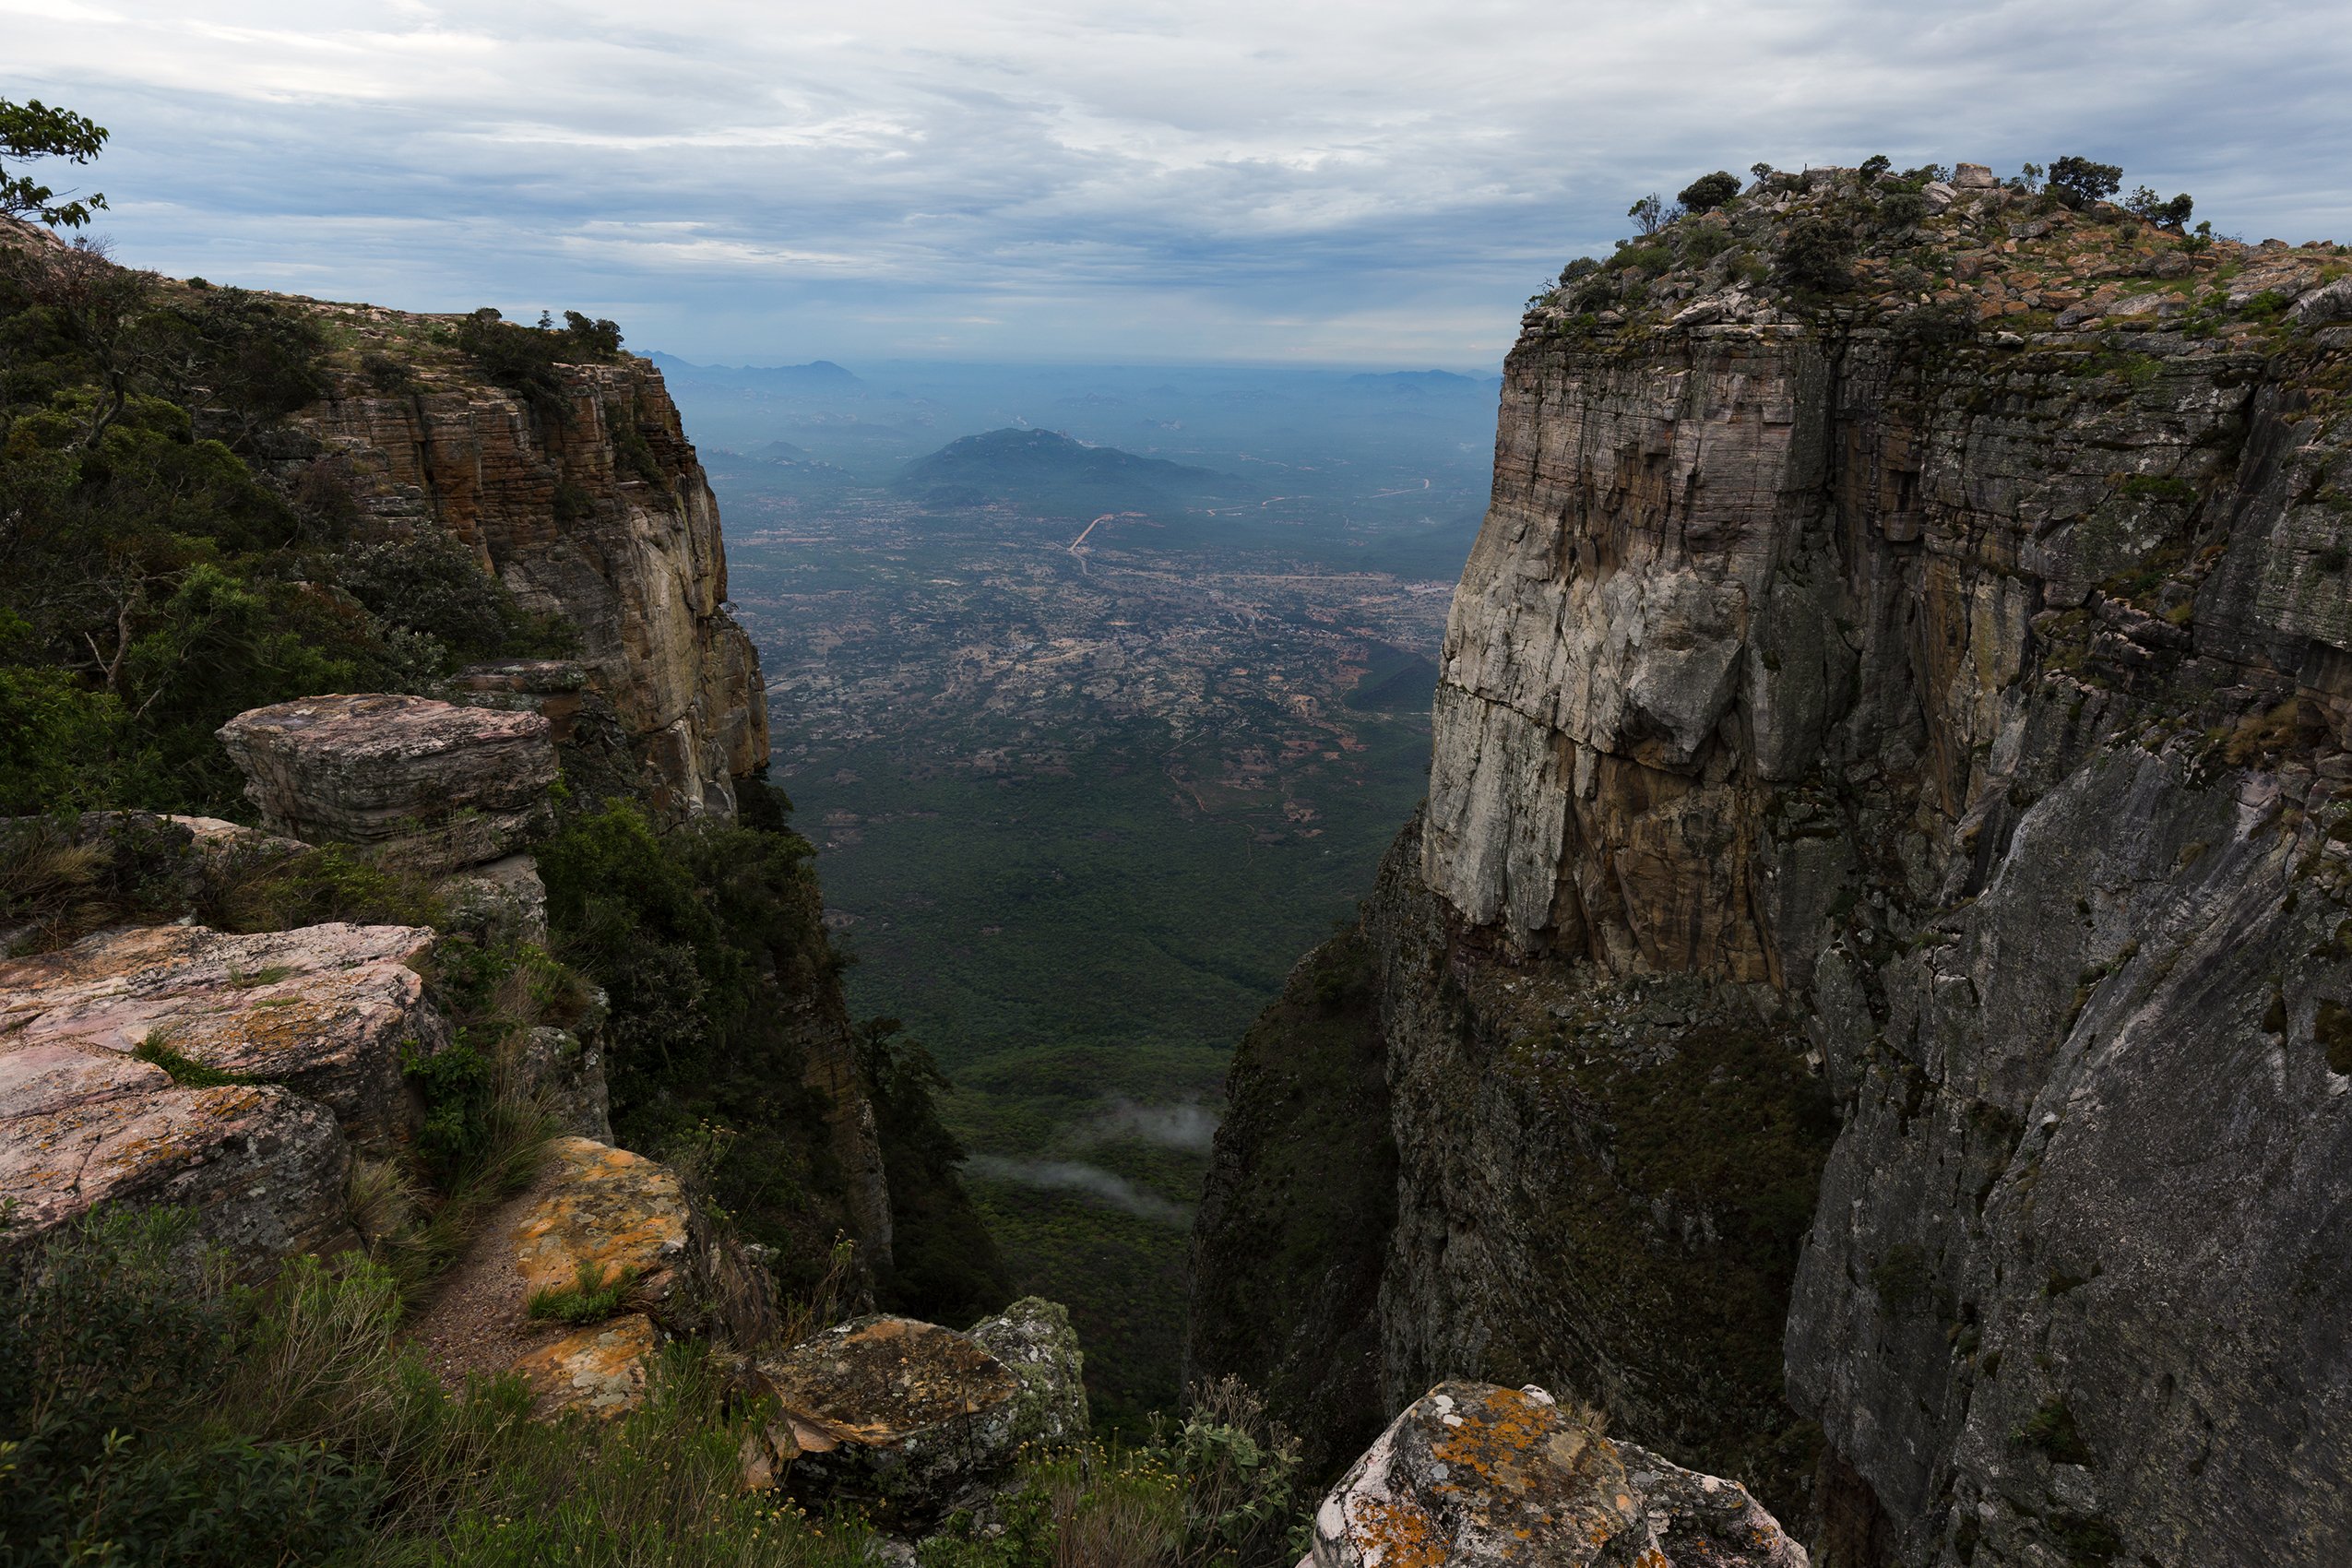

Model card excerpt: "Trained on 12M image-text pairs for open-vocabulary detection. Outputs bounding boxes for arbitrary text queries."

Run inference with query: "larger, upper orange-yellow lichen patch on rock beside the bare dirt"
[513,1138,689,1307]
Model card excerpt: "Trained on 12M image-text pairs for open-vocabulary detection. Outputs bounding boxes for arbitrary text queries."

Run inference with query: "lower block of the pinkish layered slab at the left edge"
[0,1034,355,1269]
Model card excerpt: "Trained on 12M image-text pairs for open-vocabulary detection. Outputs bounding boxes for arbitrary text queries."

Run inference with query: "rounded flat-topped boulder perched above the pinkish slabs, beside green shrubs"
[219,694,555,867]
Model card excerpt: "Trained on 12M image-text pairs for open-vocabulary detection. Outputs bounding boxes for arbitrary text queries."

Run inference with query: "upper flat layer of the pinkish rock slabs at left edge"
[0,921,449,1147]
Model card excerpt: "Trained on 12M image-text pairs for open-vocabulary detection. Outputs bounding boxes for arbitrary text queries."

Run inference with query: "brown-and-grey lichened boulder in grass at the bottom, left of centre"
[760,1298,1087,1526]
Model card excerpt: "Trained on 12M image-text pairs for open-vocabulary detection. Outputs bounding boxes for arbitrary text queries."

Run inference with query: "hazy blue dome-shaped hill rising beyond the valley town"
[898,430,1249,513]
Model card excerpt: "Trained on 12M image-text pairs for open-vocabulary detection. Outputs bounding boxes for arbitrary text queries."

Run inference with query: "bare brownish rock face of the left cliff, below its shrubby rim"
[294,331,766,815]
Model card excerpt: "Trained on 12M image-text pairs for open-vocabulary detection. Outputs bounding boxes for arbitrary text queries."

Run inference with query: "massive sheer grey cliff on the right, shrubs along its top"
[1193,170,2352,1568]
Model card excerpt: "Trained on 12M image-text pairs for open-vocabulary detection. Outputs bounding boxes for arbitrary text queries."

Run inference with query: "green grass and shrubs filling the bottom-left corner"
[0,1211,871,1568]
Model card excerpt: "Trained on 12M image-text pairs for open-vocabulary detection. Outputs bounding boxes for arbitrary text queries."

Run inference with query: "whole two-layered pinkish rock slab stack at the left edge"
[0,924,447,1265]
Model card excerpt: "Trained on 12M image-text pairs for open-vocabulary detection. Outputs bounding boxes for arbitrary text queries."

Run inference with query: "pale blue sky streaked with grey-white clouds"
[0,0,2352,372]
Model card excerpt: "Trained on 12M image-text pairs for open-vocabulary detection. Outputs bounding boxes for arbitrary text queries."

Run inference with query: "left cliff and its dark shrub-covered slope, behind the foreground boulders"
[0,217,1002,1314]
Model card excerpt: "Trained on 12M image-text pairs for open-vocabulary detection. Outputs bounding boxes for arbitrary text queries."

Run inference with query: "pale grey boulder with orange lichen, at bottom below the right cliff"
[1301,1383,1806,1568]
